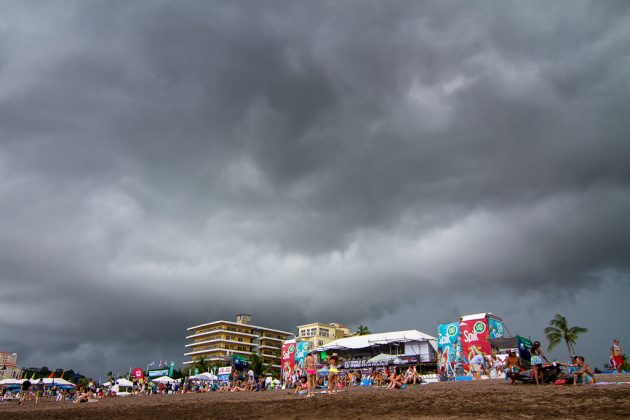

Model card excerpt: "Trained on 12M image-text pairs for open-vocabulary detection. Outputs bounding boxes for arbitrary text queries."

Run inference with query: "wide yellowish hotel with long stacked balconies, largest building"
[184,314,293,370]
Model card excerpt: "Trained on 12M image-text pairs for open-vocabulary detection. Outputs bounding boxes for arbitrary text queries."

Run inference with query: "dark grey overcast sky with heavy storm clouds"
[0,0,630,375]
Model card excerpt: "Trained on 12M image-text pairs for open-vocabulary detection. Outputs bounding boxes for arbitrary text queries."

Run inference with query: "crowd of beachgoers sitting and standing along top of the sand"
[0,339,623,404]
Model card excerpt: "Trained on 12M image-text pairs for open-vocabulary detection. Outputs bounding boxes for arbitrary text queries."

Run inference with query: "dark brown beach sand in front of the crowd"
[0,375,630,419]
